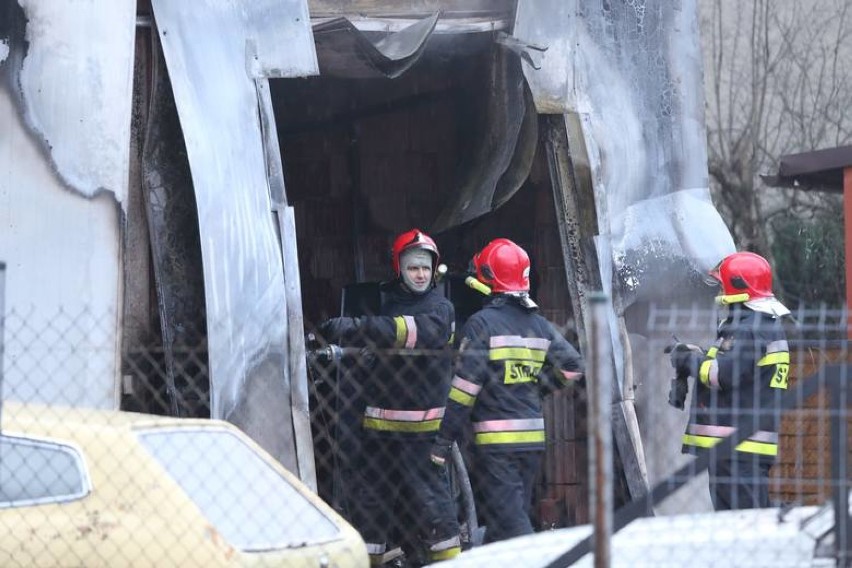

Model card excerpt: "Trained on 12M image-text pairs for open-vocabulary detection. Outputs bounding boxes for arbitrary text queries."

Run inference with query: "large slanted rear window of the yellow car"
[139,429,340,551]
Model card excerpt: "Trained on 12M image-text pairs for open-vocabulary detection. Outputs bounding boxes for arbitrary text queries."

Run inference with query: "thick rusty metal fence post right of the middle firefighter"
[587,292,613,568]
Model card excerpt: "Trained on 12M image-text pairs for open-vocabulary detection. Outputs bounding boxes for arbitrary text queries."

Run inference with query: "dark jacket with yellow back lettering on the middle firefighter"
[439,294,583,451]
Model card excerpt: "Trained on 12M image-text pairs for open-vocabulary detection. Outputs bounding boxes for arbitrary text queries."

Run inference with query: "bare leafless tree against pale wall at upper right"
[699,0,852,259]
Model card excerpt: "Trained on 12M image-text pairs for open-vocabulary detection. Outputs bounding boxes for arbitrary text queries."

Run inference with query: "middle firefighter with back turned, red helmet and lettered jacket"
[431,239,583,542]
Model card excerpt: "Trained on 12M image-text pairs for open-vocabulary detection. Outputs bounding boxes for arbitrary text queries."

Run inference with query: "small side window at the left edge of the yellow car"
[0,435,89,508]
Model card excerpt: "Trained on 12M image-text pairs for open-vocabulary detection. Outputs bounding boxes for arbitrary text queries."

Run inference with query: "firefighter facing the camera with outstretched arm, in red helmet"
[319,229,461,565]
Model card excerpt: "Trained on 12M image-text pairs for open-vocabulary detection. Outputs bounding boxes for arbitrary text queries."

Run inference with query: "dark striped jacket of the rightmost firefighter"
[683,304,790,463]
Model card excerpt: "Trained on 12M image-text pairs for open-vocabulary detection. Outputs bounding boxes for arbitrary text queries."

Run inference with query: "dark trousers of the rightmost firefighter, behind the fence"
[709,455,771,511]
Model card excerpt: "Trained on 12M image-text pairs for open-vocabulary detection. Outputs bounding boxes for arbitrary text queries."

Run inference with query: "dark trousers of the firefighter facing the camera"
[351,438,459,560]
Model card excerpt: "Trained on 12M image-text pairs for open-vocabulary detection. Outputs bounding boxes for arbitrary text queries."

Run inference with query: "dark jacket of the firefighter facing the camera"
[322,284,455,438]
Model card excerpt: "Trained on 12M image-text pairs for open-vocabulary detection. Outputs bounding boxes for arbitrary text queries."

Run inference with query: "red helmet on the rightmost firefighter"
[710,252,774,304]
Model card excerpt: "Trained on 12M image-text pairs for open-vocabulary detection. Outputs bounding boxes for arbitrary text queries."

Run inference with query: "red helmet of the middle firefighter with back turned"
[473,239,530,293]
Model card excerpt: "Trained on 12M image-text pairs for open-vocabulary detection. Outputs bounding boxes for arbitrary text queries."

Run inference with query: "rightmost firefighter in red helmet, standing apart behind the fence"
[671,252,790,510]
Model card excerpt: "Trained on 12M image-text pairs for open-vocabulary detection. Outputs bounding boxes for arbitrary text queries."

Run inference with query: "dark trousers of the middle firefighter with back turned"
[473,448,544,542]
